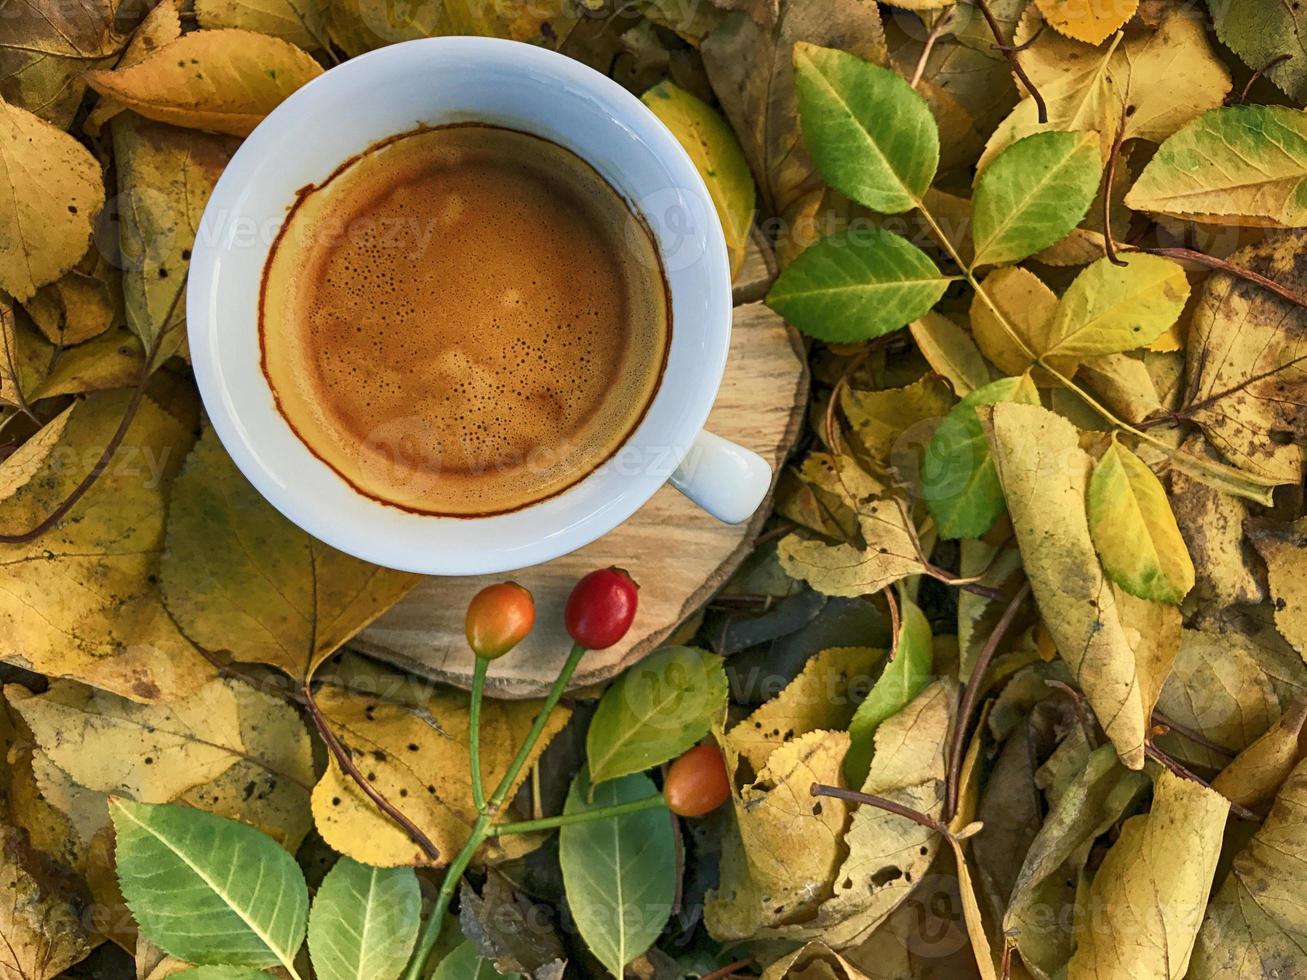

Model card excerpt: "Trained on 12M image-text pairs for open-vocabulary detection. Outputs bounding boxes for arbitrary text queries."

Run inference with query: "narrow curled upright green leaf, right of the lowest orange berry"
[844,588,935,787]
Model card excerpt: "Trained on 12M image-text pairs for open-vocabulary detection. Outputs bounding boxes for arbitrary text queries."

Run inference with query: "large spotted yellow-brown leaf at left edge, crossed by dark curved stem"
[0,392,213,702]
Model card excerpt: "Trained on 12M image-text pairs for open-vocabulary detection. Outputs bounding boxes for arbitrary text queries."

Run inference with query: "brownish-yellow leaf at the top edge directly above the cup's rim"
[326,0,576,56]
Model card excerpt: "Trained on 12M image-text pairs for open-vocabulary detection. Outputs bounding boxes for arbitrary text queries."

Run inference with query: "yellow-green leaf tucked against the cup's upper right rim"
[640,81,757,277]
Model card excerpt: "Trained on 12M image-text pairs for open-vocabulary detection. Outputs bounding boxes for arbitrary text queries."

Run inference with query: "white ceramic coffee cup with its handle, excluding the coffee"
[187,37,771,575]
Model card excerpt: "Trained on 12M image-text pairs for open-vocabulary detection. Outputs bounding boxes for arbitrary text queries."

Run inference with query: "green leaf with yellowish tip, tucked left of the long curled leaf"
[921,375,1039,538]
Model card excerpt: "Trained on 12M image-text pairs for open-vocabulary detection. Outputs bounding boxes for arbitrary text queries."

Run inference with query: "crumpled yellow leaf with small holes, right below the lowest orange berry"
[704,732,848,941]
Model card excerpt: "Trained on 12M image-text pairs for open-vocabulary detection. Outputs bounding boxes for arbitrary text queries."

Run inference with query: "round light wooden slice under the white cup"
[350,237,808,698]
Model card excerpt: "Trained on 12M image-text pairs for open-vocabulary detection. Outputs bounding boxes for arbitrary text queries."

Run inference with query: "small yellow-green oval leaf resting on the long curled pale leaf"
[1087,442,1193,602]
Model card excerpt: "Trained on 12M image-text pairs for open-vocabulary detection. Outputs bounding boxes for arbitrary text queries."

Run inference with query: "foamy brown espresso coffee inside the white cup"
[259,124,672,516]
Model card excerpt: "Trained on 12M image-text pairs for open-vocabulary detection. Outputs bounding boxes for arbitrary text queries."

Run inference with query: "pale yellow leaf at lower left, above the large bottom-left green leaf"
[4,681,244,804]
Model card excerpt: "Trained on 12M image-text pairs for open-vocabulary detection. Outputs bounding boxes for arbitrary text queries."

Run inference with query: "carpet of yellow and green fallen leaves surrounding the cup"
[0,0,1307,980]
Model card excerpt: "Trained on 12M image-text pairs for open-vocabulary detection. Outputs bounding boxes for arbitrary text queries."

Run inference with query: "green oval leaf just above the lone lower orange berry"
[586,647,727,783]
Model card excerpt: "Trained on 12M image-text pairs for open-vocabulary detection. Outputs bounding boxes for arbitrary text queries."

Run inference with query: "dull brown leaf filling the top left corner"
[0,0,128,129]
